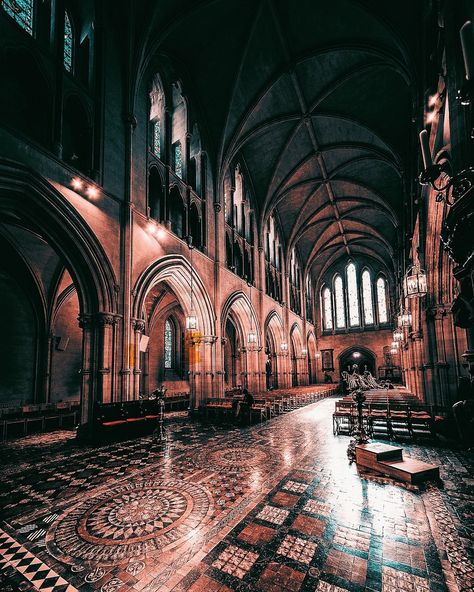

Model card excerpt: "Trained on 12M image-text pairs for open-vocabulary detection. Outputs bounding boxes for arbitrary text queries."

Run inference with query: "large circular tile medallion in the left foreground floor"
[46,480,212,563]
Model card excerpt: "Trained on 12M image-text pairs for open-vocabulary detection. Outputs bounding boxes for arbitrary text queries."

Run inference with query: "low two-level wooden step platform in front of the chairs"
[356,443,439,485]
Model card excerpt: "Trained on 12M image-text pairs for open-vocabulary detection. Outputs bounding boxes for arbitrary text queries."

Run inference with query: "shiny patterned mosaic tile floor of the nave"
[0,399,474,592]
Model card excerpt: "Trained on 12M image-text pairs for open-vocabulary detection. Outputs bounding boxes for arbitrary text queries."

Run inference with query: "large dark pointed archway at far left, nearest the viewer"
[0,161,115,424]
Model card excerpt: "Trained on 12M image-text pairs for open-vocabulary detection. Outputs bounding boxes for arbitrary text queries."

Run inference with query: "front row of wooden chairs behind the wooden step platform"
[333,400,438,439]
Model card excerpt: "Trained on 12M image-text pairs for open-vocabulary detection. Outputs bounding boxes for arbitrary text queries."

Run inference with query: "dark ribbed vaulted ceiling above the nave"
[137,0,423,278]
